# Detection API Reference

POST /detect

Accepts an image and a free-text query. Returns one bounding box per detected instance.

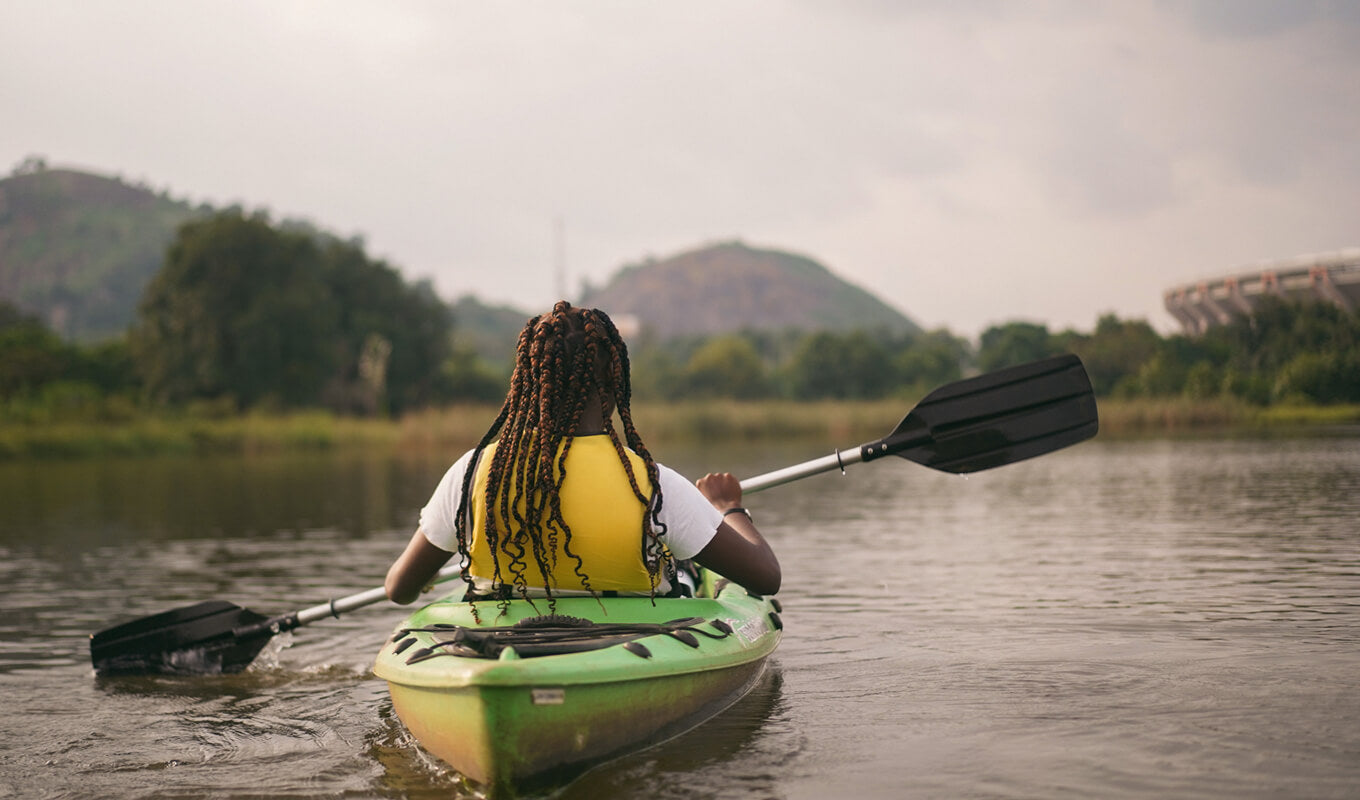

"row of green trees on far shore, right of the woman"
[622,298,1360,405]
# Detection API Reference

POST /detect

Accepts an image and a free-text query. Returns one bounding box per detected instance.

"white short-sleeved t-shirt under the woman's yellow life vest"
[420,450,722,592]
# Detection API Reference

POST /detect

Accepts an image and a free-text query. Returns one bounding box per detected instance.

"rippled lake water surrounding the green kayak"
[0,429,1360,800]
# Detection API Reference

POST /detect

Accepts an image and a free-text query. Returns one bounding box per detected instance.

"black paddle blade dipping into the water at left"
[90,600,273,675]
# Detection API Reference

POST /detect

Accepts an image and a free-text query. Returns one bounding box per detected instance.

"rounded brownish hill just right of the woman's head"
[581,242,921,337]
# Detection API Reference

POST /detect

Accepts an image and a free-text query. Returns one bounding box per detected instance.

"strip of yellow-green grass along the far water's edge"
[0,399,1360,459]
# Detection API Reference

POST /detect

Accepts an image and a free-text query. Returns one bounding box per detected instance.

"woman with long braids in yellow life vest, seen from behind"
[385,301,781,604]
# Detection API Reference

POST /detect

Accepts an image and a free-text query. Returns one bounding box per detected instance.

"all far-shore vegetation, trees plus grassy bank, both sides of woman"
[0,210,1360,457]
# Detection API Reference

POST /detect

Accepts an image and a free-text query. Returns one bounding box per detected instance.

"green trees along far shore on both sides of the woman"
[0,210,1360,420]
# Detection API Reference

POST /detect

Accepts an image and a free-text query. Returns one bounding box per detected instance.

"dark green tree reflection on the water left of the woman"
[0,452,447,547]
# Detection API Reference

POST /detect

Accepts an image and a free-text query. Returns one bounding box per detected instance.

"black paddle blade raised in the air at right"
[862,354,1099,473]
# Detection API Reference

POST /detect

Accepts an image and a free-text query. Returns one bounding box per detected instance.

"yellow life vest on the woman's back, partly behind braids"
[469,435,651,592]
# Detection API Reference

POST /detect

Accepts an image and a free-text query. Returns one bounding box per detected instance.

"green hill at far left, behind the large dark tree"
[0,159,197,341]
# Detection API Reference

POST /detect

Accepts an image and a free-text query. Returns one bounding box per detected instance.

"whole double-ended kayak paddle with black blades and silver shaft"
[90,355,1098,675]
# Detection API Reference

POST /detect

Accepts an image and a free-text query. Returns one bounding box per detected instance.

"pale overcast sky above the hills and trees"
[0,0,1360,337]
